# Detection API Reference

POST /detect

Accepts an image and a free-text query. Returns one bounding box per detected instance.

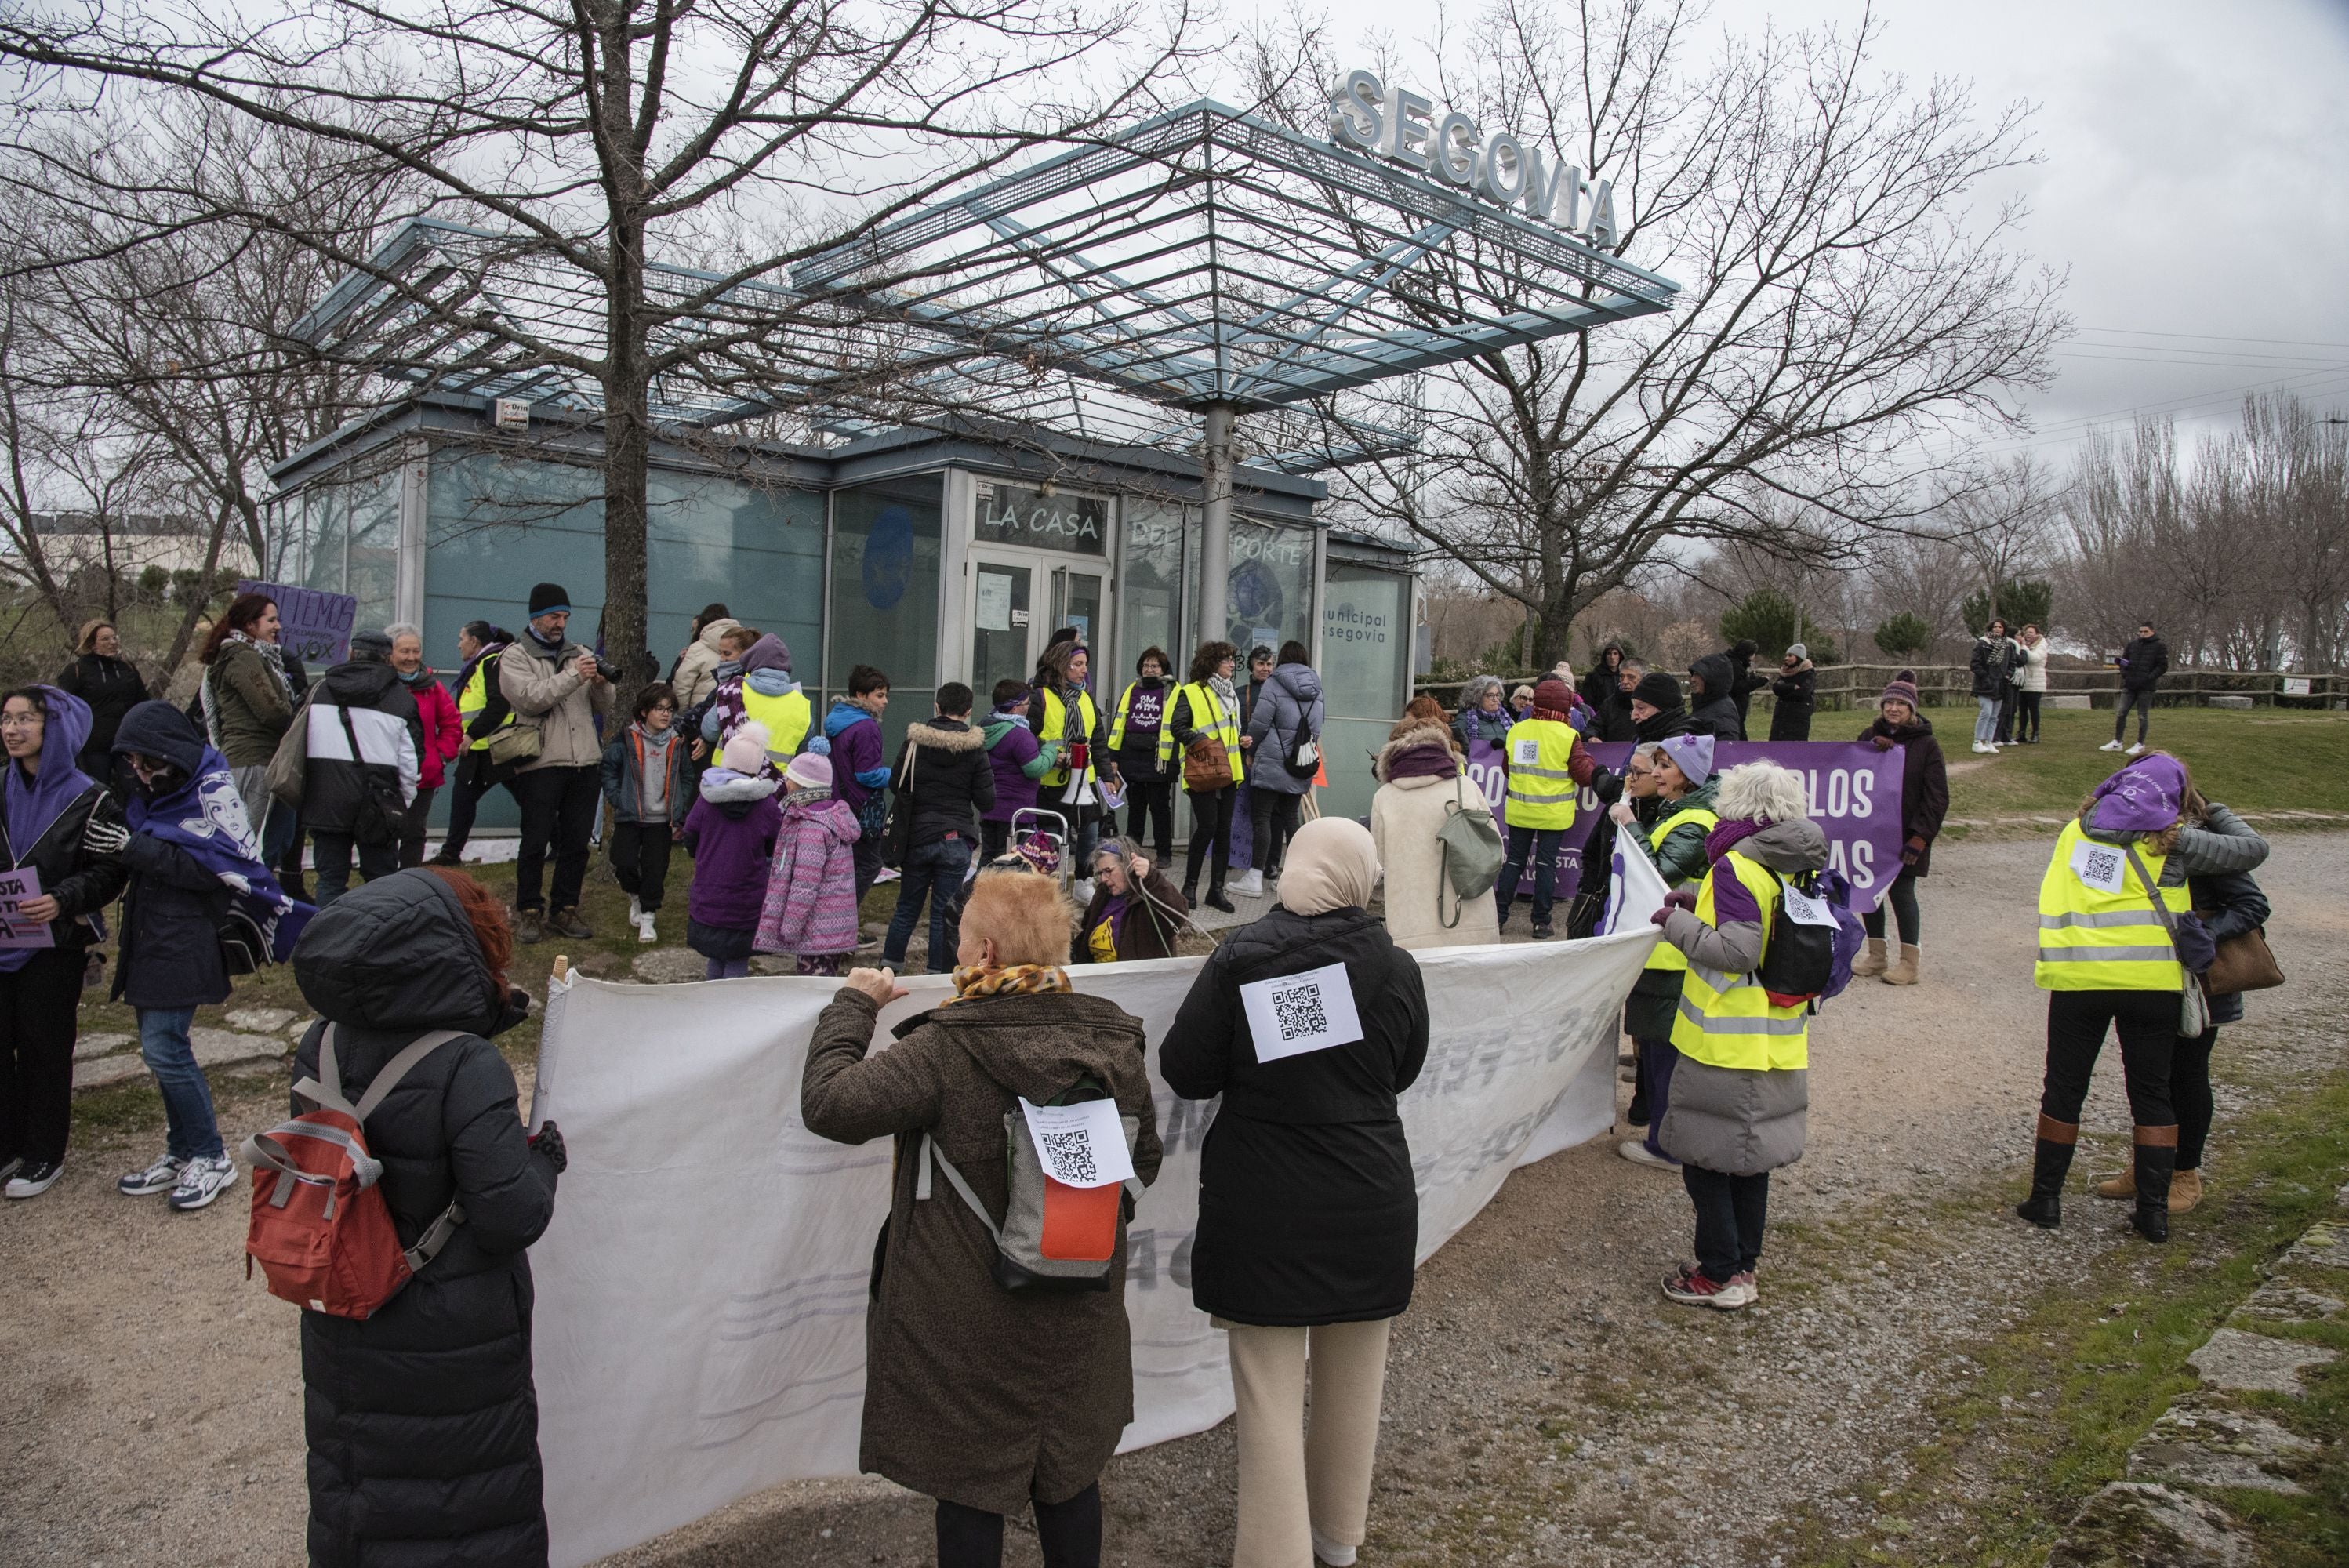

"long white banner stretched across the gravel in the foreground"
[531,925,1656,1568]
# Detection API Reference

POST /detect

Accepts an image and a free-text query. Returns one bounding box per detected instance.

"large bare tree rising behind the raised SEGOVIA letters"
[1292,0,2064,662]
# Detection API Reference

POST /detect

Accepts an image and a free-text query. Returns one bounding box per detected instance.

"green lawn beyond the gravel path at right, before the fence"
[1926,706,2349,836]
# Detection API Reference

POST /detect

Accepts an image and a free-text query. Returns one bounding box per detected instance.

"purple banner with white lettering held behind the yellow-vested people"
[1469,739,1903,911]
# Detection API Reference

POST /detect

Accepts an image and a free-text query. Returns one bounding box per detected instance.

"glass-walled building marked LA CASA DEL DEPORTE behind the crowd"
[273,392,1417,831]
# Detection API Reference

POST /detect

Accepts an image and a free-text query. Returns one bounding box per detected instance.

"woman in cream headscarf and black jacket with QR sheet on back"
[1158,817,1429,1568]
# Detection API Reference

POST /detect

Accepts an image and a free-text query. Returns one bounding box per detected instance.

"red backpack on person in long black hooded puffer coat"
[245,1023,465,1319]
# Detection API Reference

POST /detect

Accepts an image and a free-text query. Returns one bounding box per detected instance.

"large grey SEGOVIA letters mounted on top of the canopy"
[1330,71,1623,251]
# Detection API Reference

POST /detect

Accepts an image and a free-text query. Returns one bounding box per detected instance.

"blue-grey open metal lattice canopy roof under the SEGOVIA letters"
[294,101,1677,472]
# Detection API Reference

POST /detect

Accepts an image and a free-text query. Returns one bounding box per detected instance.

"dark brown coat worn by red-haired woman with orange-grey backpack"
[801,990,1158,1514]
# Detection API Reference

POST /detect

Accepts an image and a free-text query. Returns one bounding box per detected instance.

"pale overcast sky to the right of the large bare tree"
[1287,0,2349,465]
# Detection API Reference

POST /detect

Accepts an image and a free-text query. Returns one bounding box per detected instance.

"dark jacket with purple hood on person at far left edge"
[0,688,129,970]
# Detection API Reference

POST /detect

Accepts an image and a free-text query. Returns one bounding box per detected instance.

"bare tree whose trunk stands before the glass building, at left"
[0,0,1189,699]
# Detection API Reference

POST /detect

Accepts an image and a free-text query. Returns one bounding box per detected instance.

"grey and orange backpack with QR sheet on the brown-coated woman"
[913,1077,1142,1291]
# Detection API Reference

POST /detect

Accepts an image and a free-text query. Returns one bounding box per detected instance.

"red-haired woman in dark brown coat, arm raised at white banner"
[799,871,1158,1568]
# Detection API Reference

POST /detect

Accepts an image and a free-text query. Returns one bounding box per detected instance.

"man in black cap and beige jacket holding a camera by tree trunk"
[498,583,620,942]
